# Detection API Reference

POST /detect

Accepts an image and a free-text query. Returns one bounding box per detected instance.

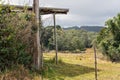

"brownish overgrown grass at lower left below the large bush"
[0,65,41,80]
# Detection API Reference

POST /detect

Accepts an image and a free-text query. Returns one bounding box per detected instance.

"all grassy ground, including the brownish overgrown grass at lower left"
[0,49,120,80]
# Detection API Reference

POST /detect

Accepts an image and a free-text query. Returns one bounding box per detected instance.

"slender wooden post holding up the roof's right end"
[53,14,58,64]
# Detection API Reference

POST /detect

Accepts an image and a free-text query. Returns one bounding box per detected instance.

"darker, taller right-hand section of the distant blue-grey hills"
[80,26,104,32]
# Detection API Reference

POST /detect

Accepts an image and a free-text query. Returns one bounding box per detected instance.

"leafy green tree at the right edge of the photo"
[97,14,120,62]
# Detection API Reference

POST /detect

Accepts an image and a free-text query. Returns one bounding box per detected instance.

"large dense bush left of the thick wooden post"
[0,6,32,71]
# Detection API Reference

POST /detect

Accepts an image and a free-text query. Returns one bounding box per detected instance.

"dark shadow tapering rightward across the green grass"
[42,60,100,80]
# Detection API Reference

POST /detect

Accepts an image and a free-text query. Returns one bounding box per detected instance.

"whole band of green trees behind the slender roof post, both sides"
[42,26,97,52]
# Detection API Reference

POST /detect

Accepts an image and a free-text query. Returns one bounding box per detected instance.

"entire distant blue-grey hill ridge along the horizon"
[63,26,104,32]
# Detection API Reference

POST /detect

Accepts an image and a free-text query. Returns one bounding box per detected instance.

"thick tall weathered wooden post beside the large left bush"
[33,0,42,70]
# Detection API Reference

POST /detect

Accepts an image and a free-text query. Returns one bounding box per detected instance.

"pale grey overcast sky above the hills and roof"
[1,0,120,27]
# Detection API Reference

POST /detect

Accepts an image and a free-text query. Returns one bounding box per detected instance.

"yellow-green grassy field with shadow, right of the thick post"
[43,49,120,80]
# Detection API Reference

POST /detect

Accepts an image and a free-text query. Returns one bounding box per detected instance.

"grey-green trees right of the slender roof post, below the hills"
[58,30,96,51]
